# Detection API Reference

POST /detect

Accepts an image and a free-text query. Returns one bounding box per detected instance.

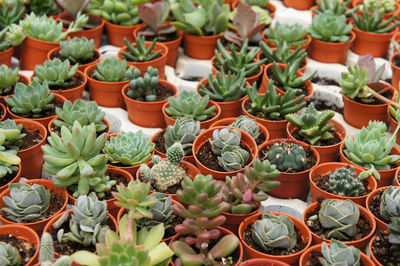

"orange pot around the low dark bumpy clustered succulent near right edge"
[310,162,376,206]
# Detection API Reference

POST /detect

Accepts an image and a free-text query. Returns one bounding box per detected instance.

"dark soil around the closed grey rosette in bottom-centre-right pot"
[243,220,307,256]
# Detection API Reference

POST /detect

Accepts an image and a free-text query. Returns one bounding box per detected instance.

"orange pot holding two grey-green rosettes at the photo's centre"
[192,126,258,180]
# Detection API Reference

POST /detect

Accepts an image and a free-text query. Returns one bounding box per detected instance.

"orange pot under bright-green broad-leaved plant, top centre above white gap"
[183,33,221,60]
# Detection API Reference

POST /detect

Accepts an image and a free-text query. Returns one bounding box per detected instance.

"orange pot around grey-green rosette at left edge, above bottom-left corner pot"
[0,179,68,234]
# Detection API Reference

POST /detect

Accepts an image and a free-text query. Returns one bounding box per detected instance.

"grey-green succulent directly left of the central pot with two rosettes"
[164,115,203,156]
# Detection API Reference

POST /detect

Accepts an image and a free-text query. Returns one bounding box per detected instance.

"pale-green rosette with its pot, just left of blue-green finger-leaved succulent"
[85,56,133,107]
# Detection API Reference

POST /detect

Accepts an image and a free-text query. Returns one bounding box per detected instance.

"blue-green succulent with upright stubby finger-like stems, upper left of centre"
[126,66,160,102]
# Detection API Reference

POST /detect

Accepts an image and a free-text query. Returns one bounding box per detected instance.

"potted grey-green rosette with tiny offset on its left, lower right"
[303,199,376,249]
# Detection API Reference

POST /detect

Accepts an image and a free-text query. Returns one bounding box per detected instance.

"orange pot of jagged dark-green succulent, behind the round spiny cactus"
[286,119,346,163]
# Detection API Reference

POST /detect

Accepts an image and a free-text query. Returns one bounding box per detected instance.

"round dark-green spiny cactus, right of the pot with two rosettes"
[265,142,307,172]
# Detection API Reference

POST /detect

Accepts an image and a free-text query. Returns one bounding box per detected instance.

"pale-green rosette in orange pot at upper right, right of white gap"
[309,10,355,64]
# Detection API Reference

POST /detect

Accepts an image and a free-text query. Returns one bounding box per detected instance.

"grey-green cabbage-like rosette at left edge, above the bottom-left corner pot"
[2,183,50,223]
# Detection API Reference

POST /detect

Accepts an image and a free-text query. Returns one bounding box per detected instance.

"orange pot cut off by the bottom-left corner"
[0,224,40,266]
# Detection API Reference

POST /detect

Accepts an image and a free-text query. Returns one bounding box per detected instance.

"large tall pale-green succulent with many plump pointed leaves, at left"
[41,121,116,198]
